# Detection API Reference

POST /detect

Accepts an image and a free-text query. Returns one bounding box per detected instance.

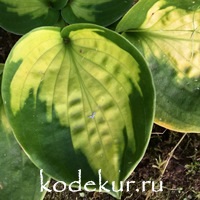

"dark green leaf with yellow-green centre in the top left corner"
[0,0,67,34]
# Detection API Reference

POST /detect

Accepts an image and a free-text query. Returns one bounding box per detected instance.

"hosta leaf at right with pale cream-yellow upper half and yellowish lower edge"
[117,0,200,132]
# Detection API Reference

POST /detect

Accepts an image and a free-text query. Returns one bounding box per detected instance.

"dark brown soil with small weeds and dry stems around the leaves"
[0,29,200,200]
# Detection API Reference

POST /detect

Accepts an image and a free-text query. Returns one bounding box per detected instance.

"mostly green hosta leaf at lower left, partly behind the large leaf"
[0,64,48,200]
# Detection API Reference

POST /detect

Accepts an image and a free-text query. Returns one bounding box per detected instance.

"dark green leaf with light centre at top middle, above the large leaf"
[62,0,133,26]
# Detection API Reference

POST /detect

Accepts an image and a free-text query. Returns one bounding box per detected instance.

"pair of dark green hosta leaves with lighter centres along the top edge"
[0,0,133,34]
